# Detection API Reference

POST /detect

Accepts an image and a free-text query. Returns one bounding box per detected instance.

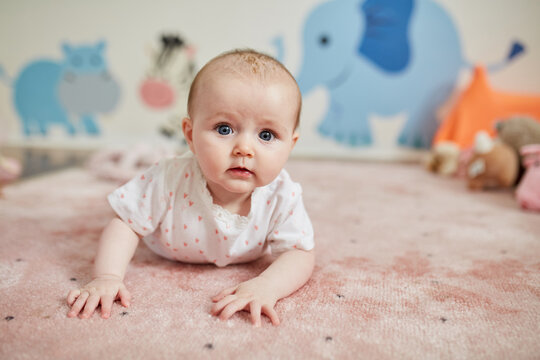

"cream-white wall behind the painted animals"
[0,0,540,158]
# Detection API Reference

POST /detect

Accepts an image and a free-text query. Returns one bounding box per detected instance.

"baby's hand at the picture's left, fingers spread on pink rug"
[67,275,131,319]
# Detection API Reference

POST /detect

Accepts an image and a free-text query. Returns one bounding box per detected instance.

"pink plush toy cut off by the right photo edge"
[516,144,540,211]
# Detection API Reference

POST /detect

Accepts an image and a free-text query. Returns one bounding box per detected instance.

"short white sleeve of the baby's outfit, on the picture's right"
[267,182,315,254]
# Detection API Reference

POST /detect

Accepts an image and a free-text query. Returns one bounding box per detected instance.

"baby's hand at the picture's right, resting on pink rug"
[212,277,279,327]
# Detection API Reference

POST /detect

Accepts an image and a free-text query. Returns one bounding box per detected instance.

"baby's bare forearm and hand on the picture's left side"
[67,218,139,319]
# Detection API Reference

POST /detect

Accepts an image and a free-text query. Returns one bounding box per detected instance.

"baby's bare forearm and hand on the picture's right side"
[212,250,315,327]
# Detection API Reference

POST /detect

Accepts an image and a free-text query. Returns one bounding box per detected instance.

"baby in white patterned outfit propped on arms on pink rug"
[67,50,314,326]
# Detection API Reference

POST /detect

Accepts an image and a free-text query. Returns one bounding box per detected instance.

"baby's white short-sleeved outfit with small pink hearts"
[108,152,314,266]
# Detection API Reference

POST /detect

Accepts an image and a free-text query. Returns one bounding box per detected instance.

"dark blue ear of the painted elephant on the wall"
[358,0,414,73]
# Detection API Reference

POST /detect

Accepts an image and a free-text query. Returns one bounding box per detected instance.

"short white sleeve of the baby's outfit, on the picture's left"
[107,160,174,236]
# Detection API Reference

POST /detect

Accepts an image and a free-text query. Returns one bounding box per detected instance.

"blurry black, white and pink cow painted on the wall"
[140,34,195,138]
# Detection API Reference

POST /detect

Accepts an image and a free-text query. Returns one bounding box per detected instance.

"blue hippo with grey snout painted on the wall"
[5,42,120,136]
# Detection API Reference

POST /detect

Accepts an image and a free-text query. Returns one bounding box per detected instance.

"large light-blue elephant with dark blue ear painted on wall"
[297,0,523,148]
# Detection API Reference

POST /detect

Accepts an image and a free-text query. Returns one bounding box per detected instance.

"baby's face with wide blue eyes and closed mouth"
[183,73,298,200]
